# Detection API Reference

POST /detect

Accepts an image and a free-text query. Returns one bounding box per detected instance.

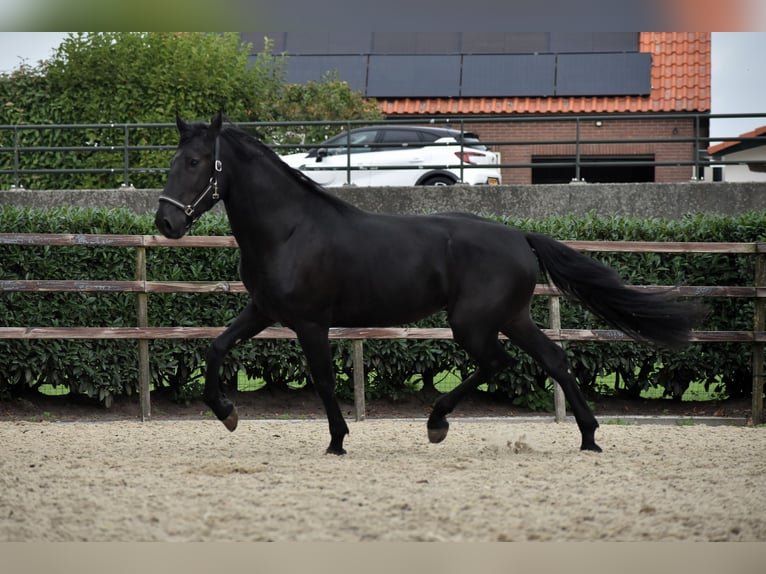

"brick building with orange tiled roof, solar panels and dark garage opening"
[242,32,711,184]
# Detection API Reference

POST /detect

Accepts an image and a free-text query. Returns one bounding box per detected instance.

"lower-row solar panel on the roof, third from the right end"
[366,55,460,98]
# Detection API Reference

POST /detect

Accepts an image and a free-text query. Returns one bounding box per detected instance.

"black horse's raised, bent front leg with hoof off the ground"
[203,303,271,431]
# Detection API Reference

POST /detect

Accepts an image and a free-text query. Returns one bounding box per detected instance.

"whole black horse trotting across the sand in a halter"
[156,113,708,454]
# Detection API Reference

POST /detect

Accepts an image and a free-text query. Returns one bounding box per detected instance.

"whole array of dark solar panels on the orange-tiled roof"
[255,32,651,98]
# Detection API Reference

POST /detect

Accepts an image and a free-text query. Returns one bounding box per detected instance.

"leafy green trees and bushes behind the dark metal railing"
[0,32,380,189]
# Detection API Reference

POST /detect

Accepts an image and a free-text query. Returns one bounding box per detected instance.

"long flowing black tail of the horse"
[525,233,704,347]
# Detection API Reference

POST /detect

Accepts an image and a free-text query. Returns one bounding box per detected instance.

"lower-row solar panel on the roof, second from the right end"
[460,54,556,97]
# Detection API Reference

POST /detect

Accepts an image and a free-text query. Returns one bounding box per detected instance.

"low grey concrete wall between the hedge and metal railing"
[0,182,766,219]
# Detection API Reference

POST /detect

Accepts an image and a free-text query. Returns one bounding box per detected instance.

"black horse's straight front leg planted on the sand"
[295,324,348,454]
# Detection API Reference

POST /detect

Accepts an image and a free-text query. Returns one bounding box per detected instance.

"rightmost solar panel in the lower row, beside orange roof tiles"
[556,53,652,96]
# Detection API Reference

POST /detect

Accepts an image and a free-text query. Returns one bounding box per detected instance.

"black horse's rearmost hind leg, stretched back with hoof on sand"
[502,317,601,452]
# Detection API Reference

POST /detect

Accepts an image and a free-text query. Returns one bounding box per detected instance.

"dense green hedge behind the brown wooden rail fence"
[0,207,766,407]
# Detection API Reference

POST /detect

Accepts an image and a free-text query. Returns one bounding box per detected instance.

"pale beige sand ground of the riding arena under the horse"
[0,419,766,542]
